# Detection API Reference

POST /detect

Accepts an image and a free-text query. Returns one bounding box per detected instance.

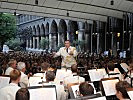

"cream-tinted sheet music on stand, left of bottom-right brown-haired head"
[102,79,119,96]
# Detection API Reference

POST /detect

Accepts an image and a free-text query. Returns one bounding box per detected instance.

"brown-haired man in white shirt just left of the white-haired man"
[5,59,17,75]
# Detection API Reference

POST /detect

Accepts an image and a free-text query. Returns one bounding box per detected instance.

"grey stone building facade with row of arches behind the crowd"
[17,13,133,55]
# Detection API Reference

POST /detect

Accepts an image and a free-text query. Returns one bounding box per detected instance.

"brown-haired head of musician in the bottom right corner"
[115,81,130,100]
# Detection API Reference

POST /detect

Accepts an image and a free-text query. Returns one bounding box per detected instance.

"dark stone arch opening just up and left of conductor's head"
[58,19,67,45]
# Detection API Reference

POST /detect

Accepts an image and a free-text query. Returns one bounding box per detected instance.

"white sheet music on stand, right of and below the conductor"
[88,69,106,82]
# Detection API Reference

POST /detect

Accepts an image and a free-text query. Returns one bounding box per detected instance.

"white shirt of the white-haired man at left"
[19,72,29,88]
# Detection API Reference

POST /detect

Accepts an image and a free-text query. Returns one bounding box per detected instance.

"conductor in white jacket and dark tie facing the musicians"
[54,40,78,68]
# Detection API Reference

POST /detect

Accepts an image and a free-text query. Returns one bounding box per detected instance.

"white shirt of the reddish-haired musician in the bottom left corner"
[0,83,20,100]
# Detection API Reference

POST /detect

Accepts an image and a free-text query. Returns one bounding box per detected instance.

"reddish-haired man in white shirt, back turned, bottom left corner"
[0,69,21,100]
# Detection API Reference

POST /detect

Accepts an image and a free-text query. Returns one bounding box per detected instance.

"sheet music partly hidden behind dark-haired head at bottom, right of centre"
[71,83,96,98]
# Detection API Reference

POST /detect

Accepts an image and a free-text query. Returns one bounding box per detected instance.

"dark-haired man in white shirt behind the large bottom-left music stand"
[44,71,66,100]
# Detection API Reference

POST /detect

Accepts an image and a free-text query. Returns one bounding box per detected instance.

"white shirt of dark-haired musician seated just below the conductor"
[64,73,85,86]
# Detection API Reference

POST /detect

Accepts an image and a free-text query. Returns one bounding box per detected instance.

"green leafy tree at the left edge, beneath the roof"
[0,13,16,47]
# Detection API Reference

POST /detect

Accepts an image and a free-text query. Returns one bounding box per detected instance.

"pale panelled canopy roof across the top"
[0,0,133,21]
